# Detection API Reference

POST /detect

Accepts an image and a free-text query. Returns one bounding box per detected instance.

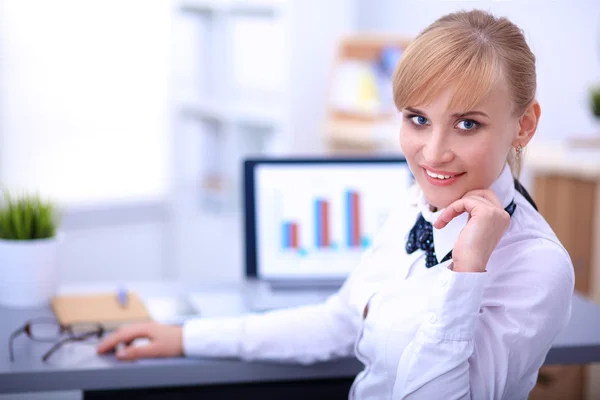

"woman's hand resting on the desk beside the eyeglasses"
[97,322,183,360]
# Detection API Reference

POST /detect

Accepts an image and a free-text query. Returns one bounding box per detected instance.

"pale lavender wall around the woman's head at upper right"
[358,0,600,140]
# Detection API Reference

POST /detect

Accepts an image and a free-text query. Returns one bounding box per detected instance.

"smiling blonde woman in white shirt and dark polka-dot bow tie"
[98,11,574,400]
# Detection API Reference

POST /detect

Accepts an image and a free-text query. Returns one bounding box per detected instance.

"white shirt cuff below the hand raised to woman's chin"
[420,263,489,340]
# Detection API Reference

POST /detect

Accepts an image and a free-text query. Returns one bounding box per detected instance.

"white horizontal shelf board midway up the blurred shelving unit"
[182,101,284,125]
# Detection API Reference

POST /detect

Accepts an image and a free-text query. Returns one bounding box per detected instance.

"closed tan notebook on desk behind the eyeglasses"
[51,292,152,329]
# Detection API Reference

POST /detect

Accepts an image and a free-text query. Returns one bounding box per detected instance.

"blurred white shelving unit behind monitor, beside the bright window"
[175,0,290,211]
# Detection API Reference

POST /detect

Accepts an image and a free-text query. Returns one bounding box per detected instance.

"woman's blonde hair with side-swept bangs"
[393,10,536,177]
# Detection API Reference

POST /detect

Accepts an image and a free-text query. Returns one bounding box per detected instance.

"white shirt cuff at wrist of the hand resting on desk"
[183,317,244,357]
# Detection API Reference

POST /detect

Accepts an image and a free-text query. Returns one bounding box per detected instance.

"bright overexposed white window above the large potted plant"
[0,0,171,203]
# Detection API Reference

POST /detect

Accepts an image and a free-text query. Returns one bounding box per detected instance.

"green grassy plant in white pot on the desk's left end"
[0,191,59,308]
